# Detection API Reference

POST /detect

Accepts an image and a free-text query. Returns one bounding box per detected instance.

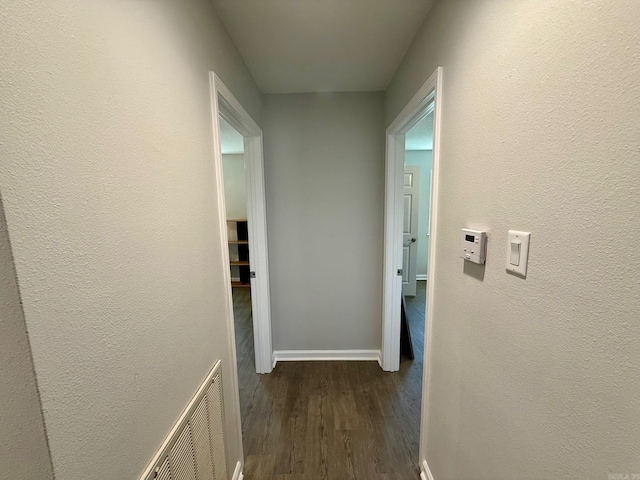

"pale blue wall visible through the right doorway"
[404,150,433,275]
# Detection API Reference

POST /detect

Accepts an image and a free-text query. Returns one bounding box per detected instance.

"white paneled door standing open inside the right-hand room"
[402,165,420,296]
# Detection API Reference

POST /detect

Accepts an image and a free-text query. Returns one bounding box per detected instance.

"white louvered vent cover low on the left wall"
[142,362,228,480]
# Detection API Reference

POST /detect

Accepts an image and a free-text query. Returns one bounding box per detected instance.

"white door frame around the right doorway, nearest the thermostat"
[381,67,442,376]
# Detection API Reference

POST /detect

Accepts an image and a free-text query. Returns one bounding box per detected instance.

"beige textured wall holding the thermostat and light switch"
[386,0,640,480]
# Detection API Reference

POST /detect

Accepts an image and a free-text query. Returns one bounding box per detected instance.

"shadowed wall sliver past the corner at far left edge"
[0,193,53,480]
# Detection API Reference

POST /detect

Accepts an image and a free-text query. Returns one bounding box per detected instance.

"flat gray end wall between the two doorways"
[262,92,384,350]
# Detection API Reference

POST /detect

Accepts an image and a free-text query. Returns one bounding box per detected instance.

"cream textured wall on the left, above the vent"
[0,0,261,480]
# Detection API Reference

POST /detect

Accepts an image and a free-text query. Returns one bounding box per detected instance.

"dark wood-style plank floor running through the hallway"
[233,282,426,480]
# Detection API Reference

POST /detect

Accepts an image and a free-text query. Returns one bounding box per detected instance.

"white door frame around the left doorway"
[209,72,273,376]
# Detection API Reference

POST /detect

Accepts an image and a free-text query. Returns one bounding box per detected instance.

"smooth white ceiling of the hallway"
[213,0,433,93]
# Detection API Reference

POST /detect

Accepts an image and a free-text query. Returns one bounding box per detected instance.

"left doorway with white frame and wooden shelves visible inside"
[210,72,273,388]
